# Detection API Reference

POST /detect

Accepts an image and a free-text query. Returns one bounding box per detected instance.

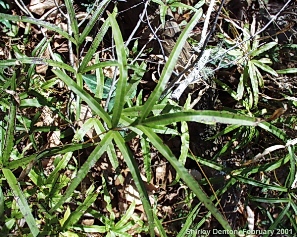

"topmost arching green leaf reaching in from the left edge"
[0,13,77,44]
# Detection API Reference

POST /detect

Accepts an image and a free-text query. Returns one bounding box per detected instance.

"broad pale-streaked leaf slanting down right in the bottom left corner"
[2,168,39,237]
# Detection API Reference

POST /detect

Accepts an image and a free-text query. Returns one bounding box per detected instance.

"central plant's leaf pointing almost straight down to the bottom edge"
[114,132,155,237]
